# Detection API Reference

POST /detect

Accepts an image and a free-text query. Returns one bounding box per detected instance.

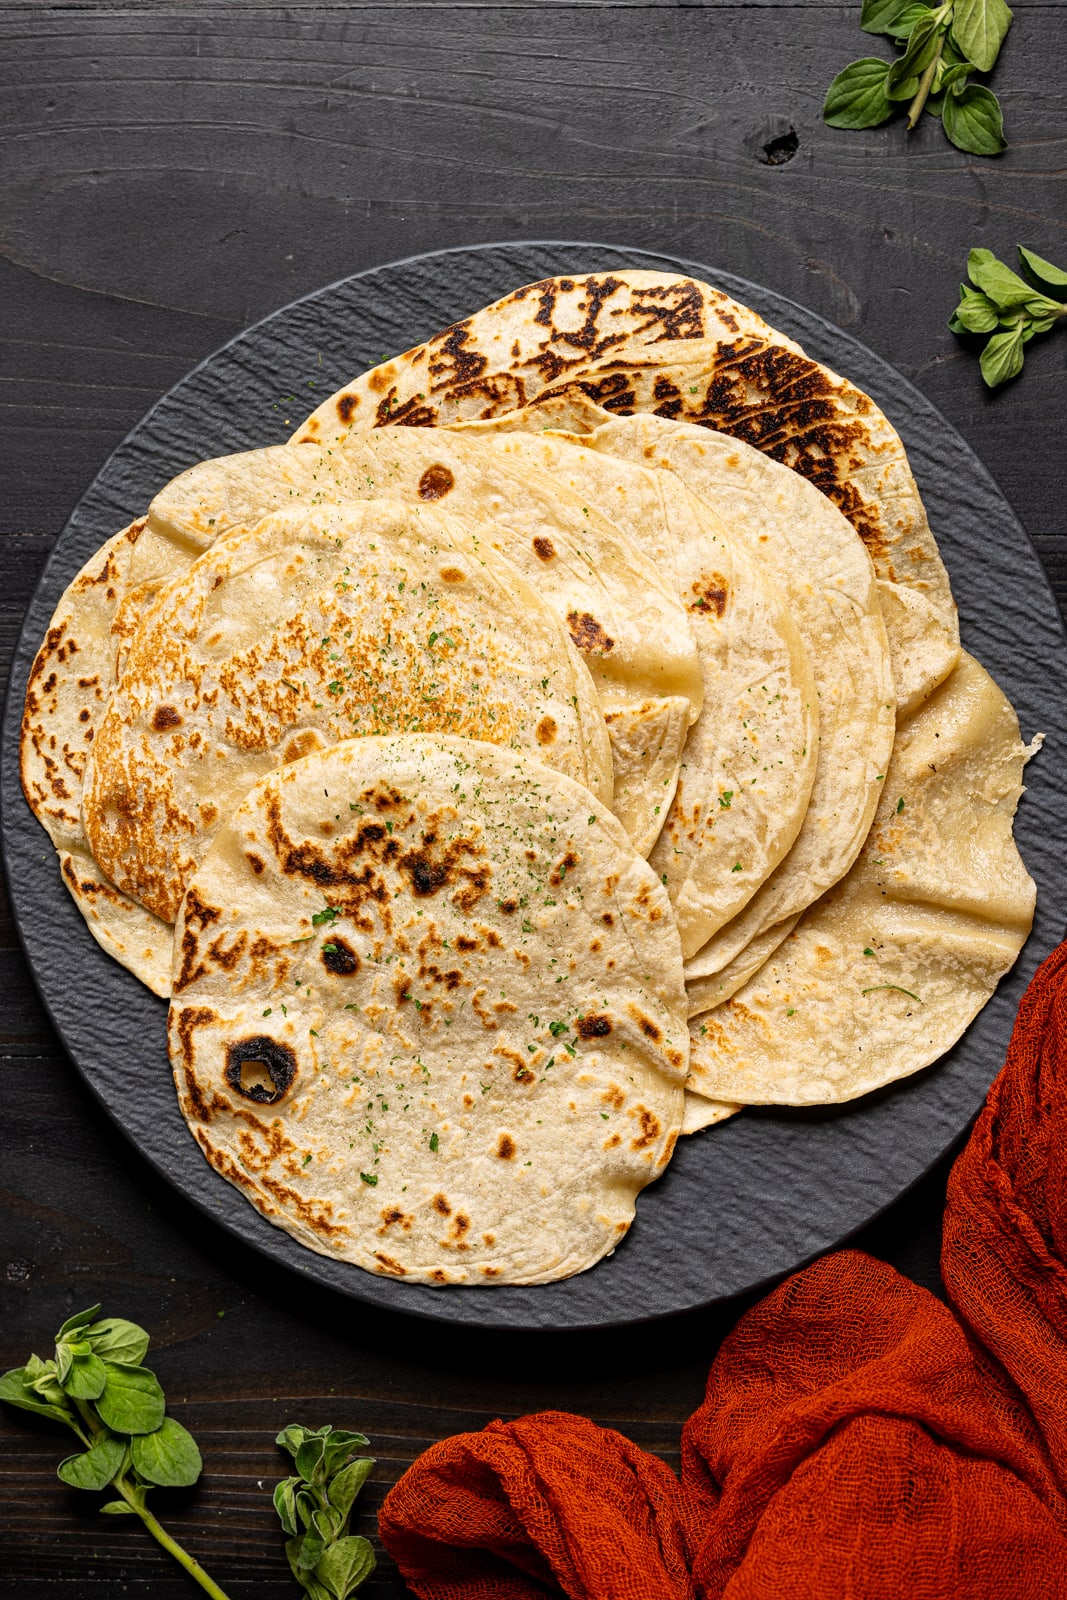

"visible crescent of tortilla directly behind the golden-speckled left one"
[143,429,702,854]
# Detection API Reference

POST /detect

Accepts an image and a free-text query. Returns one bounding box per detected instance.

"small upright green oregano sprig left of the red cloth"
[274,1422,374,1600]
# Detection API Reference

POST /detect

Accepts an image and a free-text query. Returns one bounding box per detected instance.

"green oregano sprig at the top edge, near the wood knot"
[822,0,1013,155]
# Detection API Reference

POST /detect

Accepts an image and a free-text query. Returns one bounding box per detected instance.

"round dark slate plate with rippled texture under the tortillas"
[2,243,1067,1328]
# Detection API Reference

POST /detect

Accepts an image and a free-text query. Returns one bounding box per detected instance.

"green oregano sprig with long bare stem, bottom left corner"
[0,1306,227,1600]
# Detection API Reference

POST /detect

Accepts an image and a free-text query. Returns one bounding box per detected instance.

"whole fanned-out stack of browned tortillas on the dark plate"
[22,272,1033,1283]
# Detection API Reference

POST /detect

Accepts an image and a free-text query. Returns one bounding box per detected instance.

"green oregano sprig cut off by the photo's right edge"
[949,245,1067,389]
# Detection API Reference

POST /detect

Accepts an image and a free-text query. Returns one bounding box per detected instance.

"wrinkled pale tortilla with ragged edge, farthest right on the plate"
[689,654,1035,1106]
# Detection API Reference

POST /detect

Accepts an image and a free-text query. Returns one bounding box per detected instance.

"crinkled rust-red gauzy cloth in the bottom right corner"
[379,944,1067,1600]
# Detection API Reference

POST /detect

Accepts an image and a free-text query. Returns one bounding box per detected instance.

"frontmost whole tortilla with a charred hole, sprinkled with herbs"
[170,736,688,1285]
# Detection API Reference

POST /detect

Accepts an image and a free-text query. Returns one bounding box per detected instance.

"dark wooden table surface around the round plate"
[0,0,1067,1600]
